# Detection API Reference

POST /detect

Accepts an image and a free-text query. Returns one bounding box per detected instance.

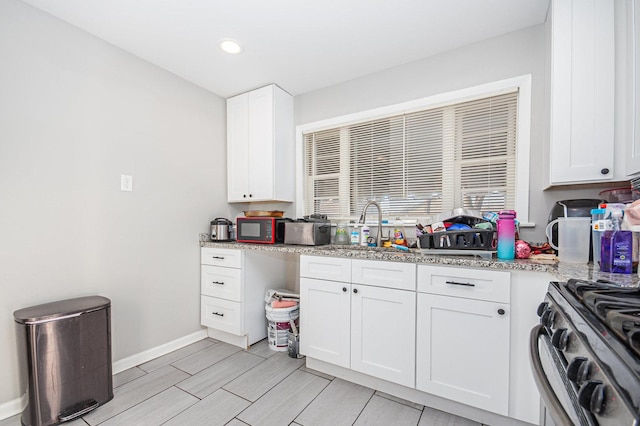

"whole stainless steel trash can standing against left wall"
[13,296,113,426]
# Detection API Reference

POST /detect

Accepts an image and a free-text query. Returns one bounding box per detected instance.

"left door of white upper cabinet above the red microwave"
[227,93,249,202]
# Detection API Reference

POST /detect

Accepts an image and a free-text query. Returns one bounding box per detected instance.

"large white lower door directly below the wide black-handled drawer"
[416,293,509,416]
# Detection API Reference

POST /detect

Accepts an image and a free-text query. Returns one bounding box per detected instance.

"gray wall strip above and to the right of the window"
[295,25,616,242]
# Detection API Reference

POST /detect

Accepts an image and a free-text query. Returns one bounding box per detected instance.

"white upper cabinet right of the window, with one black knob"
[546,0,624,185]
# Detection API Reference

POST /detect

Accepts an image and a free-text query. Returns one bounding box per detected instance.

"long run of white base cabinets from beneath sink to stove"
[300,255,551,425]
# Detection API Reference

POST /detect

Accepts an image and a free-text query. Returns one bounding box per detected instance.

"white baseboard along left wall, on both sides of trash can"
[0,329,207,420]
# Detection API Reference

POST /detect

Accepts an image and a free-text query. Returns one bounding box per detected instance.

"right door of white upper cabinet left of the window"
[248,86,274,201]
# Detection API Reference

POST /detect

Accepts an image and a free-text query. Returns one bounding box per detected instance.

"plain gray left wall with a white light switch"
[0,0,230,405]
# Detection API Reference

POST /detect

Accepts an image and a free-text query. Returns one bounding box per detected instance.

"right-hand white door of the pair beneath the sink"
[351,284,416,388]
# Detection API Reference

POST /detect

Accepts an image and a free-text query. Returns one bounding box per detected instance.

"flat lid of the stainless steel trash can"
[13,296,111,324]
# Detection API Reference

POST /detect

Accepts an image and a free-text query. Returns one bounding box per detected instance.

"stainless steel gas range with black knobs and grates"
[531,280,640,426]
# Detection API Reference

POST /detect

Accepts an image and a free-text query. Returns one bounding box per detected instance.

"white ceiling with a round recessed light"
[23,0,549,97]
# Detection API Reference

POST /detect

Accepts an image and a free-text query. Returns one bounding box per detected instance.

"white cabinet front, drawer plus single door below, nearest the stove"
[416,265,510,416]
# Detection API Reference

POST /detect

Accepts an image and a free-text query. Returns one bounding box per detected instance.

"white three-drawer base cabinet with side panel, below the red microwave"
[200,247,286,349]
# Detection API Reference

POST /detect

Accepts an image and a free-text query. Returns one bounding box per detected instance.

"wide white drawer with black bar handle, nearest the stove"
[418,265,511,303]
